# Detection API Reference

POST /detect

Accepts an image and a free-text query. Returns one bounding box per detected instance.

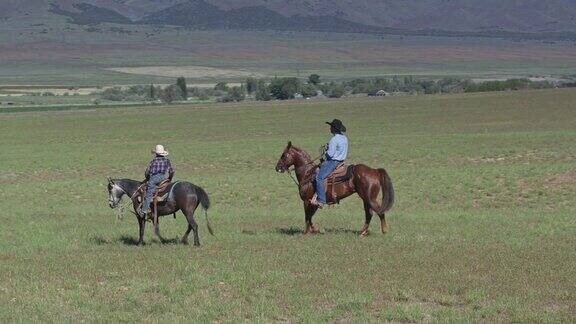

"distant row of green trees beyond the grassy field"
[100,74,555,103]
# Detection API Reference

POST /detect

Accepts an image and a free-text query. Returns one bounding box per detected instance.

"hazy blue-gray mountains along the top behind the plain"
[0,0,576,33]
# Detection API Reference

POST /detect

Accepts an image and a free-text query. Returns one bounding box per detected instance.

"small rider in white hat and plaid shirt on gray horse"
[138,144,175,218]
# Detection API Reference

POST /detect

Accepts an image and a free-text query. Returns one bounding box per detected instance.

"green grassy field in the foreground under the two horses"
[0,90,576,322]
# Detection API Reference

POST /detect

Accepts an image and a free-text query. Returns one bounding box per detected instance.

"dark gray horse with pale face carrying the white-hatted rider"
[108,178,214,246]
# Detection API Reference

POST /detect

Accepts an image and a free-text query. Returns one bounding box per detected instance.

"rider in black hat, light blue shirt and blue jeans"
[310,119,348,206]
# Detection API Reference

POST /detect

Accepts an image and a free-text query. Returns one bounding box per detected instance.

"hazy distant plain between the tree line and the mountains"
[0,22,576,87]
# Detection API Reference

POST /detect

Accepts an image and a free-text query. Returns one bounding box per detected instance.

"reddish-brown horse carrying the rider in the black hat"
[276,142,394,236]
